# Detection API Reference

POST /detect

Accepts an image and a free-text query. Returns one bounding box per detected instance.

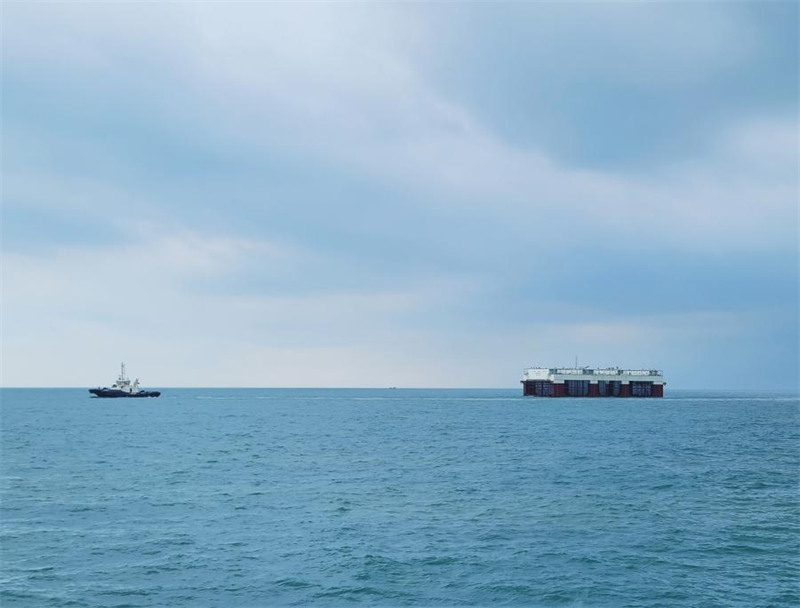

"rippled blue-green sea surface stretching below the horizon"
[0,389,800,608]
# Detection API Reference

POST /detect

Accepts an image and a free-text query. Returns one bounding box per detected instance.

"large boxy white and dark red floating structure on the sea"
[521,366,666,397]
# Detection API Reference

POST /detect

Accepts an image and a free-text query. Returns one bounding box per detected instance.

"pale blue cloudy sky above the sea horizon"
[0,1,800,390]
